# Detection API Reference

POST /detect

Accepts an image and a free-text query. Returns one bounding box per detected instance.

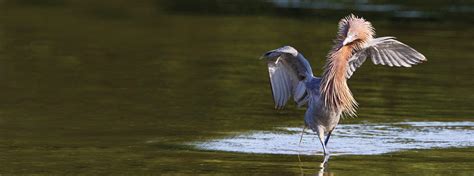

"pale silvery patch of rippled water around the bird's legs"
[191,122,474,155]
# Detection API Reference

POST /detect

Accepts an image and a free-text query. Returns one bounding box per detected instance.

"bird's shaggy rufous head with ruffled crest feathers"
[338,14,375,47]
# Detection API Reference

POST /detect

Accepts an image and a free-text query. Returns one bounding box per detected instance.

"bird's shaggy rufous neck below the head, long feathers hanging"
[320,46,357,116]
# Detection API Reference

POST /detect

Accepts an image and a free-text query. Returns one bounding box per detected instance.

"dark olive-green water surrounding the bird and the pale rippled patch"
[0,0,474,175]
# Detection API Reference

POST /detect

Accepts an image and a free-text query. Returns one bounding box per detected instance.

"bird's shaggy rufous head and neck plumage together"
[320,15,374,116]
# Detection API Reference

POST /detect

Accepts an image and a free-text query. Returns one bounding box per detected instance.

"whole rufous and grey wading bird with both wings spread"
[262,15,426,163]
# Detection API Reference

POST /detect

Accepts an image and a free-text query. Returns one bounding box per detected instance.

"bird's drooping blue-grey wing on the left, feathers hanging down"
[262,46,313,109]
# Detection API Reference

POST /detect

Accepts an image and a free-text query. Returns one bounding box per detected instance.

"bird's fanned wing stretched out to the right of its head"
[346,37,426,79]
